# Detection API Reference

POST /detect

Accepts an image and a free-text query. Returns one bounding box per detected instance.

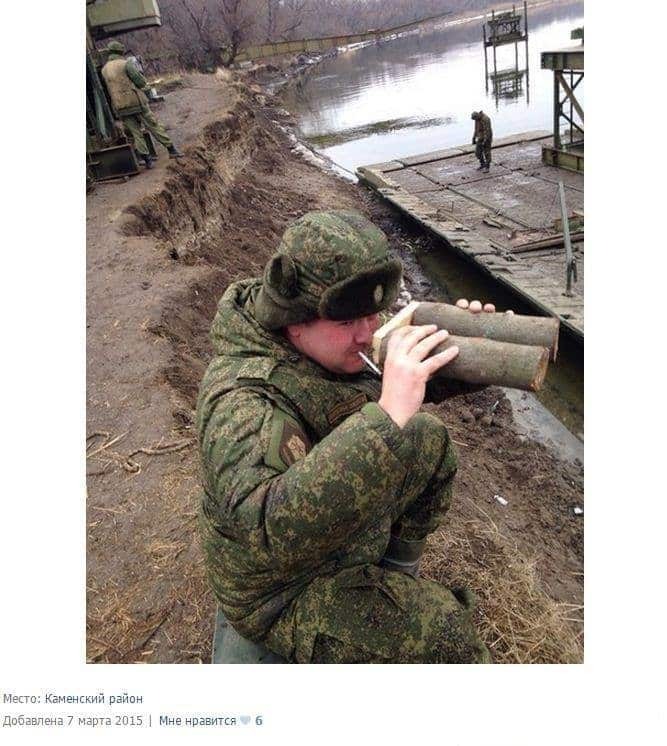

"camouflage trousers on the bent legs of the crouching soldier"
[263,414,491,663]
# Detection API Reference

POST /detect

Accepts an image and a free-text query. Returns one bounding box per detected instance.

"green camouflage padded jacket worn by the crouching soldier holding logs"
[197,280,440,640]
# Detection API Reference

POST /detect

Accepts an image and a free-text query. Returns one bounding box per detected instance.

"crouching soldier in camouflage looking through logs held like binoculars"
[197,211,490,663]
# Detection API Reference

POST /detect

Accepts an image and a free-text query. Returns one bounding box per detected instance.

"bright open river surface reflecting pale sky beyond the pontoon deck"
[286,2,583,172]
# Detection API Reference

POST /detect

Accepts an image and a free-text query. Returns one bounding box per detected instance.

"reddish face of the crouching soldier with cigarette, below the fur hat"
[286,313,380,374]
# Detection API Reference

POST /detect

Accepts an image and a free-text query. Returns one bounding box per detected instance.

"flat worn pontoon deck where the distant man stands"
[357,132,584,340]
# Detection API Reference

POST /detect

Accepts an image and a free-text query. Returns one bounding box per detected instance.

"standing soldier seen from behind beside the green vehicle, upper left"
[102,41,183,168]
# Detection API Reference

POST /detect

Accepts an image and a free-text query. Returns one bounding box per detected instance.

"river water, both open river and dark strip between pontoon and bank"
[286,2,584,439]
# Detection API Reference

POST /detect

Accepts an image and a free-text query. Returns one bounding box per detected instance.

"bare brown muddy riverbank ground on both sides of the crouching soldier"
[86,62,583,663]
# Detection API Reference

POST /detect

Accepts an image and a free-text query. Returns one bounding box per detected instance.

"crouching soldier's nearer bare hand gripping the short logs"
[378,324,459,427]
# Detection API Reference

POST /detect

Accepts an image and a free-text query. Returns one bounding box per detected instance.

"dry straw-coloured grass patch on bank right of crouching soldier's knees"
[422,502,583,663]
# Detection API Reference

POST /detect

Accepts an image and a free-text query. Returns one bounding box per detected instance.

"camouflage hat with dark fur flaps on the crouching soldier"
[255,210,402,329]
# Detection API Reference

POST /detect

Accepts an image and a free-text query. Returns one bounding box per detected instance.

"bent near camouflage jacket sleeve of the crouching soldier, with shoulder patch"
[201,389,414,563]
